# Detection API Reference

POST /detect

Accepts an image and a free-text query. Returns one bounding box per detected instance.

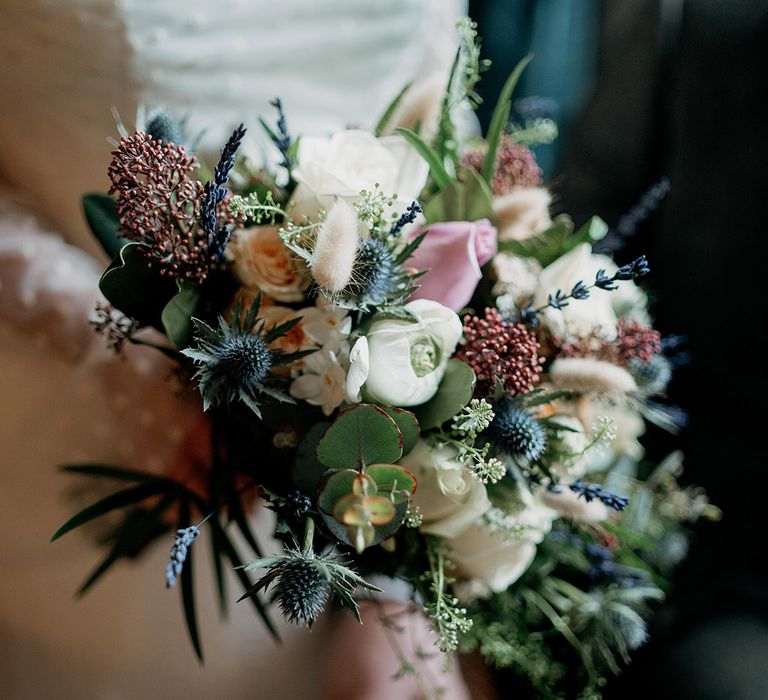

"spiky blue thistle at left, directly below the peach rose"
[182,294,314,416]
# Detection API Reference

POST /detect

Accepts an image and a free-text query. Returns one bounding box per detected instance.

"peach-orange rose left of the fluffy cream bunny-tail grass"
[227,226,305,302]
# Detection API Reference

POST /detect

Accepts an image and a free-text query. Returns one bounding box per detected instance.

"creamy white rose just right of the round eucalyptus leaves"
[400,440,491,537]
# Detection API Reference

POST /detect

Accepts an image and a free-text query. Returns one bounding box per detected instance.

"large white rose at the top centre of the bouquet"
[291,129,429,219]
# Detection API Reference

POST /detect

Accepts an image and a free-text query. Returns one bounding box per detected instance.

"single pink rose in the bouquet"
[406,219,497,311]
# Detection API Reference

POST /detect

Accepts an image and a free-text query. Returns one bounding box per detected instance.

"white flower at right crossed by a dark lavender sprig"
[533,243,644,340]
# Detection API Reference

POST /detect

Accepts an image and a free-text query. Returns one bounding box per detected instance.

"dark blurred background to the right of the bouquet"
[470,0,768,700]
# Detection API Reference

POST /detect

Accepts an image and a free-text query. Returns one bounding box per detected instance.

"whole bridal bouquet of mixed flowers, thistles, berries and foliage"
[54,24,716,697]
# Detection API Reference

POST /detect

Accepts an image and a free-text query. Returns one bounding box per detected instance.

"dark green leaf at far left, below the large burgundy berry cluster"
[99,243,178,328]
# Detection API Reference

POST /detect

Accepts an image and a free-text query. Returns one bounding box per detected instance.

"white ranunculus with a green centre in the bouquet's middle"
[362,299,462,406]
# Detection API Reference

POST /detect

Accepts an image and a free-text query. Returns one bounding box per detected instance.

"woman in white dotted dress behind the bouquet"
[0,0,474,700]
